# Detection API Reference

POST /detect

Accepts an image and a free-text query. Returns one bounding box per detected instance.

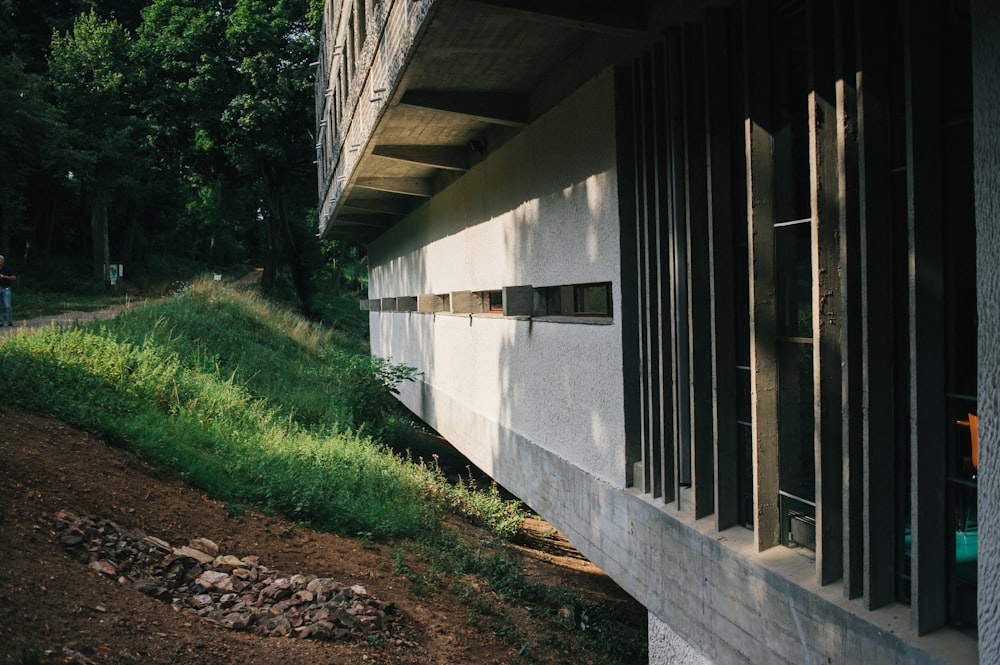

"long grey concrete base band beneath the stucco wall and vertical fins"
[424,389,972,665]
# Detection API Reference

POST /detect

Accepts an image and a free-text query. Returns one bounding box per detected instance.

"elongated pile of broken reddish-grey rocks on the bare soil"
[54,510,412,645]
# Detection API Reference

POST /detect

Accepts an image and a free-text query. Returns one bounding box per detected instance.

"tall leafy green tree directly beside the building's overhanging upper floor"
[138,0,322,310]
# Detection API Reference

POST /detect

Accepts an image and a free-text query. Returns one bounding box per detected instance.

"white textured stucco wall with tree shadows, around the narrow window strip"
[369,72,625,486]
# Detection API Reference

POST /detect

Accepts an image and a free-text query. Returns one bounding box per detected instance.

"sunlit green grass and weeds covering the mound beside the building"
[0,280,635,663]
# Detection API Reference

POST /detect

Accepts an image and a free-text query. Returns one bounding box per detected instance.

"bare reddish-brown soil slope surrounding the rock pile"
[0,411,645,665]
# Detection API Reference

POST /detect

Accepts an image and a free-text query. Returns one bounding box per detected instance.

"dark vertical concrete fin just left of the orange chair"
[903,0,954,635]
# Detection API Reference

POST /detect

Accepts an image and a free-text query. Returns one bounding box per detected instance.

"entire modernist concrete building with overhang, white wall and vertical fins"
[316,0,1000,664]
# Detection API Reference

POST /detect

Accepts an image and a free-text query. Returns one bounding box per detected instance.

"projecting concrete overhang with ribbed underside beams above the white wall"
[320,0,712,241]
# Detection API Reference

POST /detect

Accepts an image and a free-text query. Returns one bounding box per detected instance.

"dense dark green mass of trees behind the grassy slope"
[0,0,362,315]
